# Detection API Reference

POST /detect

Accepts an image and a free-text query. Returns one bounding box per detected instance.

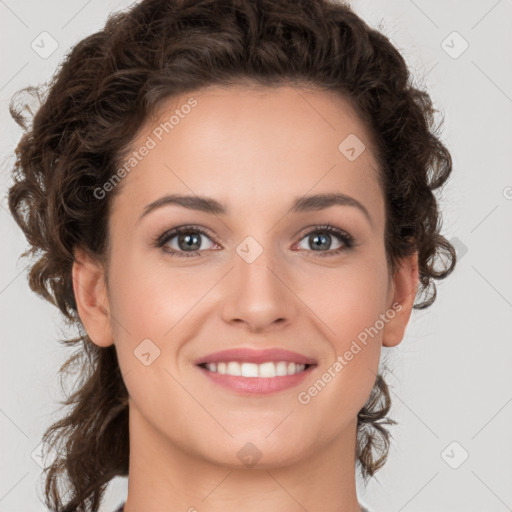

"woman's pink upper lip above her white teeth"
[195,348,316,365]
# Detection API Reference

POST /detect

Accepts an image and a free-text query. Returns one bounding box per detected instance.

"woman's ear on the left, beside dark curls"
[72,245,114,347]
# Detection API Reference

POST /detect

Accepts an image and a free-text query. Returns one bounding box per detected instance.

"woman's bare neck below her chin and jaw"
[124,403,360,512]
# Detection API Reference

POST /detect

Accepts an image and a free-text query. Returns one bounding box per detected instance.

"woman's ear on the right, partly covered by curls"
[382,252,419,347]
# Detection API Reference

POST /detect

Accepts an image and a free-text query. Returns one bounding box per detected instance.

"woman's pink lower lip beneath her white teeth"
[197,365,316,395]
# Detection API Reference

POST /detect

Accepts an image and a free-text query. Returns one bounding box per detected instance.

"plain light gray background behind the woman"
[0,0,512,512]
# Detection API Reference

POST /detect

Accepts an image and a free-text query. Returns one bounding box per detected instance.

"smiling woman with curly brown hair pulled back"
[9,0,455,512]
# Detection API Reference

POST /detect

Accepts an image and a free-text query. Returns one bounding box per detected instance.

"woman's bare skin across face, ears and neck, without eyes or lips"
[73,86,418,512]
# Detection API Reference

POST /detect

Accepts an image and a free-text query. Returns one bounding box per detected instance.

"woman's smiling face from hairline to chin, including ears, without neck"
[74,87,417,472]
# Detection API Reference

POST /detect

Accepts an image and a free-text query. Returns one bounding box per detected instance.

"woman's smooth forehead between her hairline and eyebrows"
[115,86,381,226]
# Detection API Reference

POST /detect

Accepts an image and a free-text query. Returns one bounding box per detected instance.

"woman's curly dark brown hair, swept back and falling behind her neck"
[8,0,456,512]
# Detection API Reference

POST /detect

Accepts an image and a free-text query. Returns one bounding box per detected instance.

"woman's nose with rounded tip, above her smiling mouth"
[222,242,300,332]
